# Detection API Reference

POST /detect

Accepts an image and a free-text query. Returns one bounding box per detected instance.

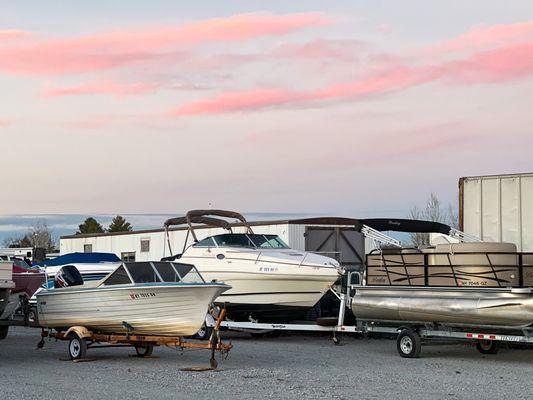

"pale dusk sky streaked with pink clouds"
[0,0,533,225]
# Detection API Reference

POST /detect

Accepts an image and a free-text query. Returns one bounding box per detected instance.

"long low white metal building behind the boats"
[60,217,375,269]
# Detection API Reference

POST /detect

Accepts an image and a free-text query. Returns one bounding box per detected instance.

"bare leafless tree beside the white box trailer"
[409,193,458,247]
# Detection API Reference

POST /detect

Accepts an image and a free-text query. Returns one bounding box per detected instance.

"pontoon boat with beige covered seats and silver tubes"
[352,220,533,328]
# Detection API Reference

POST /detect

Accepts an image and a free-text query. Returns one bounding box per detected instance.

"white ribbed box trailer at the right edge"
[459,173,533,252]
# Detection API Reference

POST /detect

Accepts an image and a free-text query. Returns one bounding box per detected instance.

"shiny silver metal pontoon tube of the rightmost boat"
[352,286,533,327]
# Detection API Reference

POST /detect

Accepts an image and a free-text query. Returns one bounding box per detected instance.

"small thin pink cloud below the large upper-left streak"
[43,80,156,97]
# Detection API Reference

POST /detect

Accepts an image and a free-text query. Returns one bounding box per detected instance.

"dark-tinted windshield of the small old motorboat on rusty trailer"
[104,261,204,286]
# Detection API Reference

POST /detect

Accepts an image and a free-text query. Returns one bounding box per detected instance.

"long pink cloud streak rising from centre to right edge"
[170,42,533,117]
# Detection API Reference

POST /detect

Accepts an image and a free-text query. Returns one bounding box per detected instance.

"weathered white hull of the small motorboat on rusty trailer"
[37,284,227,336]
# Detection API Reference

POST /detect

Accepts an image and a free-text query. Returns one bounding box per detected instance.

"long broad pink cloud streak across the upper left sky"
[0,13,331,75]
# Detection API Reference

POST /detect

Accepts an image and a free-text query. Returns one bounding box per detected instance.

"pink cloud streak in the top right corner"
[428,21,533,53]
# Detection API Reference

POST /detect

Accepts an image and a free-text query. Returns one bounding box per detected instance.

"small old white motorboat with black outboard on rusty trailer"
[37,262,229,336]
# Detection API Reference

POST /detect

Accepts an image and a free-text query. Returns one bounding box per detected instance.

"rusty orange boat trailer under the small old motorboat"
[37,310,233,369]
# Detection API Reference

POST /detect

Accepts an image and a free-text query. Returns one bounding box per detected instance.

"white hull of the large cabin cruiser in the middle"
[180,248,340,321]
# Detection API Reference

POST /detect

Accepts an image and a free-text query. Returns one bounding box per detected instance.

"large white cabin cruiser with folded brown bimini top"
[161,210,340,322]
